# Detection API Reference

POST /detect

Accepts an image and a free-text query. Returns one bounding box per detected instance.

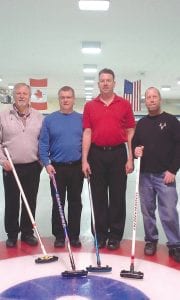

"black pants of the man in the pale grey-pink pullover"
[3,161,42,239]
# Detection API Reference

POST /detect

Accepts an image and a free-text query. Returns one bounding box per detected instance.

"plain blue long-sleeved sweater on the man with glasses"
[39,111,82,166]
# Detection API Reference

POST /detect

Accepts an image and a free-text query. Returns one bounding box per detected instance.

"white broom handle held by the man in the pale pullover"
[4,147,47,256]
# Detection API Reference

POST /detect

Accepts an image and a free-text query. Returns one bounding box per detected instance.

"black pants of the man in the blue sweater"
[50,163,84,239]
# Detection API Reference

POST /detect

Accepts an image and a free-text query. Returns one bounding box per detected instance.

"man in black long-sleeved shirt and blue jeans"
[132,87,180,262]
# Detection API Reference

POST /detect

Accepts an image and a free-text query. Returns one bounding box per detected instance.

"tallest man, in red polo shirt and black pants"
[82,69,135,250]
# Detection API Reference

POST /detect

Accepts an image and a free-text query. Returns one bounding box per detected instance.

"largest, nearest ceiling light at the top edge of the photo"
[79,0,109,10]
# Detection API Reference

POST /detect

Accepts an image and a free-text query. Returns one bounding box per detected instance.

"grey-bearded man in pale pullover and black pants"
[0,83,43,248]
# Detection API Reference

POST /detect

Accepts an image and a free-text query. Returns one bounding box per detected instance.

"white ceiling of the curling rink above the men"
[0,0,180,106]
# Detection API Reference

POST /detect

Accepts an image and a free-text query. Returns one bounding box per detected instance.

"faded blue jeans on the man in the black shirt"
[139,173,180,248]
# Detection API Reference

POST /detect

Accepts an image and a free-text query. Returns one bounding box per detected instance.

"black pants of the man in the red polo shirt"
[89,145,127,241]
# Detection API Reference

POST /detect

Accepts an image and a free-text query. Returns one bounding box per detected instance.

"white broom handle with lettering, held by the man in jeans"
[131,157,141,260]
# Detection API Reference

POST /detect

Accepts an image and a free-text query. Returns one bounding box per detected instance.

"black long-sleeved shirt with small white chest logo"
[132,112,180,174]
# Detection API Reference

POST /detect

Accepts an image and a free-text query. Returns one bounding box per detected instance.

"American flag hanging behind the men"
[124,79,141,111]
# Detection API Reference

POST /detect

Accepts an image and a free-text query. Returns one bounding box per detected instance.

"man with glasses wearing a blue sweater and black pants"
[39,86,84,247]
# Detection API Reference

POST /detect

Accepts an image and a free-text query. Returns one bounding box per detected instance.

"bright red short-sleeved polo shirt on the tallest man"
[83,94,135,146]
